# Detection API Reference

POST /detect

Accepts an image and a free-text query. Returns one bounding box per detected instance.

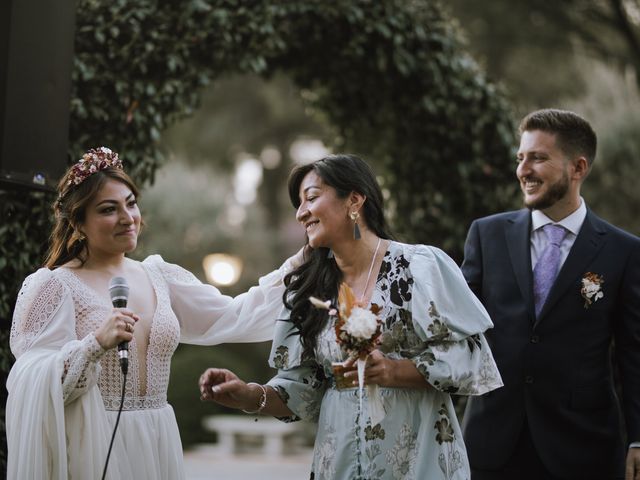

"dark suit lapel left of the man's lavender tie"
[505,210,535,323]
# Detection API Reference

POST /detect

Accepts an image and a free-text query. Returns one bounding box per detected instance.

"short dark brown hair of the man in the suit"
[518,108,598,166]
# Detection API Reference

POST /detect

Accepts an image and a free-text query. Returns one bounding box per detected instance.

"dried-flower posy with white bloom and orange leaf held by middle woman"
[309,283,385,425]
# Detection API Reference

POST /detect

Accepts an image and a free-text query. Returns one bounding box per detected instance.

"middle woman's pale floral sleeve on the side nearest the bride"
[267,316,328,422]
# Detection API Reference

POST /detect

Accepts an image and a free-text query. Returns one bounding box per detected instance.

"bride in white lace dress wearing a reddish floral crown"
[6,147,299,480]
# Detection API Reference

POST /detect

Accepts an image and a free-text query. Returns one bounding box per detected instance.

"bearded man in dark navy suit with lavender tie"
[462,109,640,480]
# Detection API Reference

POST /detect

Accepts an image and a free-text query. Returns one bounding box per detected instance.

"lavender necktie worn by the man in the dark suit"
[533,223,567,317]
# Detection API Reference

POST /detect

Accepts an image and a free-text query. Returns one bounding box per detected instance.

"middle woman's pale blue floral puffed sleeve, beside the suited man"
[409,245,502,395]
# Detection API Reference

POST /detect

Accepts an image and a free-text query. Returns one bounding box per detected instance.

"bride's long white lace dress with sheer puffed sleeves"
[6,255,289,480]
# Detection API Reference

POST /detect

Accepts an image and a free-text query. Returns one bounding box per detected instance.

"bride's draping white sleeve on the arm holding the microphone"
[6,269,129,479]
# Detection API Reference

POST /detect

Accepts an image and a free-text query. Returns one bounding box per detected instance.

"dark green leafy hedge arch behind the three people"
[0,0,515,472]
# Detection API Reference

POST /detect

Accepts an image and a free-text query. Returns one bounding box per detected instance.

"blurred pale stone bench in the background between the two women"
[202,415,299,456]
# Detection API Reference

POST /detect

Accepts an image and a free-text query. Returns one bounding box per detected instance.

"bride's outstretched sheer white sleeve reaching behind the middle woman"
[144,255,291,345]
